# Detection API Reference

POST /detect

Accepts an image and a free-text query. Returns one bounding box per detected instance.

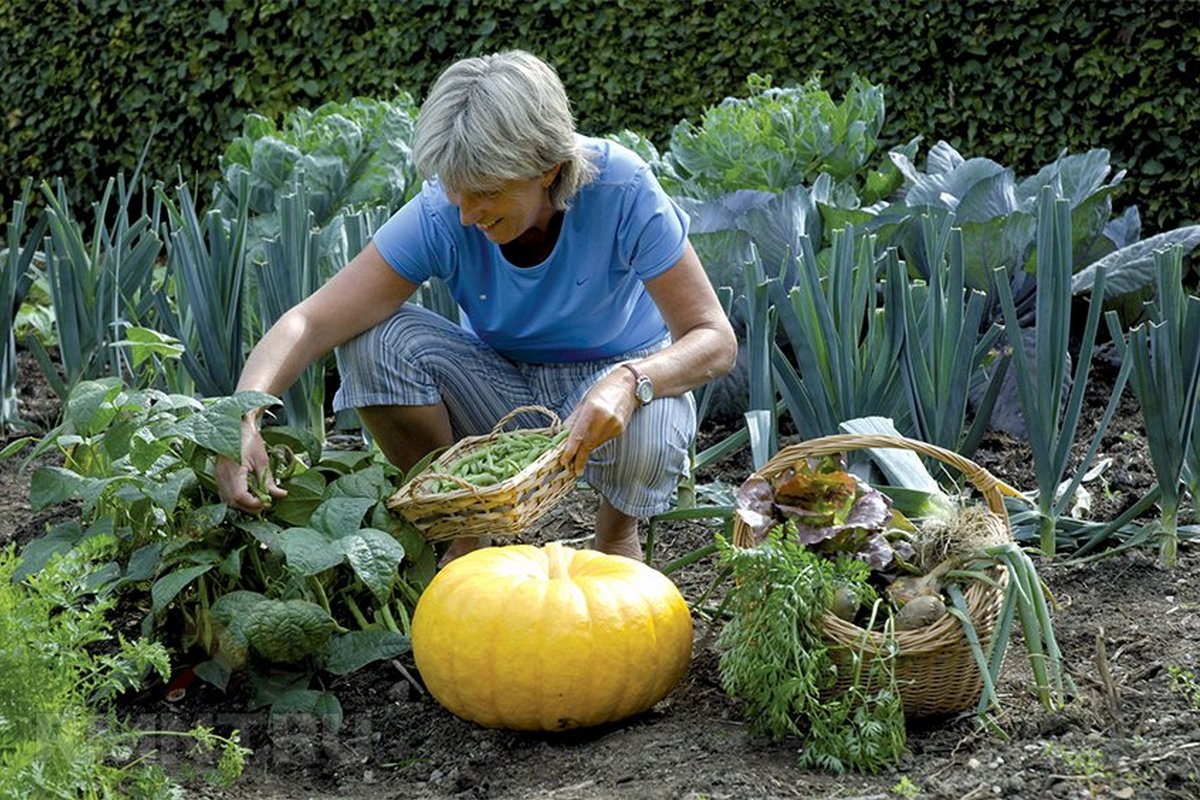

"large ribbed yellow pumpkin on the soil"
[413,542,692,730]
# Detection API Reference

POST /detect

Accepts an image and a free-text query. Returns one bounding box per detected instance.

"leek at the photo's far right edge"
[1105,246,1200,567]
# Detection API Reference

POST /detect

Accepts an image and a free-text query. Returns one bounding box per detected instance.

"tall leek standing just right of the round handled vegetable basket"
[995,186,1129,557]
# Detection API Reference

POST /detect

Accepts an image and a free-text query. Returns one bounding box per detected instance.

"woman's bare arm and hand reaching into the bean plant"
[215,243,418,512]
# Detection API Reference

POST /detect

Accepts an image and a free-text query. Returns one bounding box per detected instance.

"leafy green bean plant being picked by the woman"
[10,379,434,720]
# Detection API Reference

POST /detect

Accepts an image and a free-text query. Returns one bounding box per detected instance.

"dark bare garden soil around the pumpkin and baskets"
[0,352,1200,800]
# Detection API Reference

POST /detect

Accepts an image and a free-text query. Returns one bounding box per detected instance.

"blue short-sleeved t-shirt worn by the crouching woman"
[374,139,688,363]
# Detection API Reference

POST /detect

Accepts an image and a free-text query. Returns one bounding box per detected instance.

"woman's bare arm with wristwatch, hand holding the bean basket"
[563,242,738,475]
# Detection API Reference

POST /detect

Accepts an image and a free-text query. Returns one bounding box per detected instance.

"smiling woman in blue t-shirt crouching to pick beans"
[216,50,737,559]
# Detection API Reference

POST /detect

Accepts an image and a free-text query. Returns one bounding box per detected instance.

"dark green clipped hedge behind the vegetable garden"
[0,0,1200,230]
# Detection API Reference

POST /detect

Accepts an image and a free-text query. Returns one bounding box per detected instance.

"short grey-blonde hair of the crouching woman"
[413,50,596,210]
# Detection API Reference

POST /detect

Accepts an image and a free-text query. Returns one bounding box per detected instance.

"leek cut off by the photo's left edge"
[0,179,47,433]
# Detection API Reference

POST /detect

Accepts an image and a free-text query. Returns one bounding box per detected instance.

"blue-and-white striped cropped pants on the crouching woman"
[334,303,696,518]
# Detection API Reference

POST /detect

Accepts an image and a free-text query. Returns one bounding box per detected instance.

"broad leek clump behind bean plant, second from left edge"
[29,176,162,399]
